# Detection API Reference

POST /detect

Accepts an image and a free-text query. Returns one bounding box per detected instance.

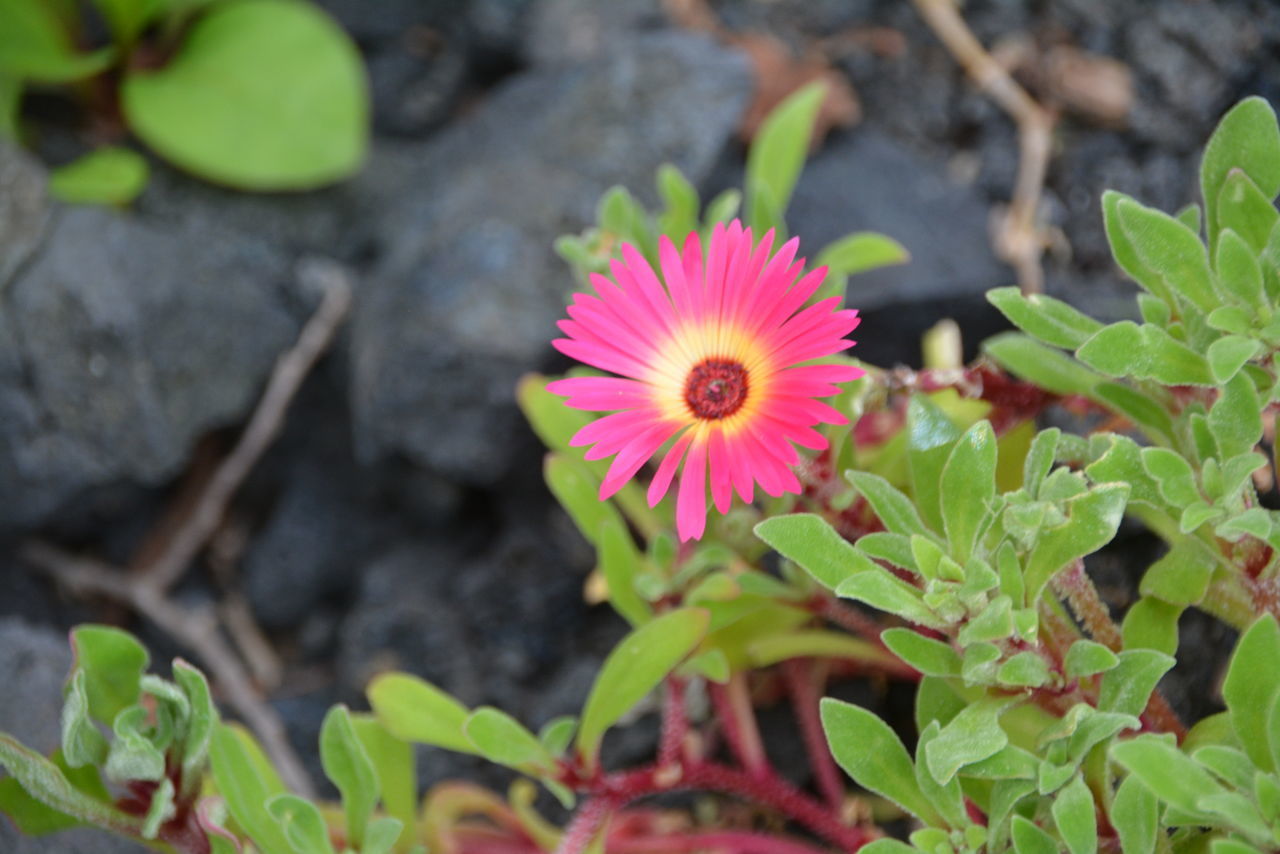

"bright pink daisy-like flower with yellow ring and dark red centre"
[548,220,864,540]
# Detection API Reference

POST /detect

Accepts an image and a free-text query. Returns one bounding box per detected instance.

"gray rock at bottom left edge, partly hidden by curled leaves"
[0,617,147,854]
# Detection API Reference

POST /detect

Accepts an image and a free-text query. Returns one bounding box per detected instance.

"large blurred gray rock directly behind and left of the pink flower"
[351,33,751,485]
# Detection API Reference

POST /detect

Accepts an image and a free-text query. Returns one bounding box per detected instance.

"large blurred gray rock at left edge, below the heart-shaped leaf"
[0,207,298,529]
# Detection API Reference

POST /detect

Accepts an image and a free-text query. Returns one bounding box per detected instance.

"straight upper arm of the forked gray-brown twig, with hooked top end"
[136,260,351,593]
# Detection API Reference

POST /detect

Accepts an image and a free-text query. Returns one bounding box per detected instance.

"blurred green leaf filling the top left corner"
[0,0,115,83]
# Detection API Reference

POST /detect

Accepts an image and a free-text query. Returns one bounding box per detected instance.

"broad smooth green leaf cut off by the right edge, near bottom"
[1222,615,1280,771]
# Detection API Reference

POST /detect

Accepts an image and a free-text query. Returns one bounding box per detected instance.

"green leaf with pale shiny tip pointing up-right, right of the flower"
[1025,484,1129,607]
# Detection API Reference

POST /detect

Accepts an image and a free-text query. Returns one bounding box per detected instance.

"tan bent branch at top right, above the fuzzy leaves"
[913,0,1053,293]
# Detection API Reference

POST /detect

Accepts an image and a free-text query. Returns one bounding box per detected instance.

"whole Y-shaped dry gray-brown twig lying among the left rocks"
[22,261,351,796]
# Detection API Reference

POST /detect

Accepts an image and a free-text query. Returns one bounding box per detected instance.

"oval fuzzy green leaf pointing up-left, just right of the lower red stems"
[820,698,946,827]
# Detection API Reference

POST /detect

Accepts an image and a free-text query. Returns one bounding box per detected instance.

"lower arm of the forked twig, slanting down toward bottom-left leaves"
[20,542,315,798]
